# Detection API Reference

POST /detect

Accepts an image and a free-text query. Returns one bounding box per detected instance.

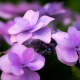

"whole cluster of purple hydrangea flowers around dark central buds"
[0,2,80,80]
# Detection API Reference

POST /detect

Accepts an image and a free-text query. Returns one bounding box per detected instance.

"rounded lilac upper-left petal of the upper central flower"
[14,17,30,30]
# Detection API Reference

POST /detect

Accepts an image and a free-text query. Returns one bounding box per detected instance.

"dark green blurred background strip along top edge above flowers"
[0,0,80,12]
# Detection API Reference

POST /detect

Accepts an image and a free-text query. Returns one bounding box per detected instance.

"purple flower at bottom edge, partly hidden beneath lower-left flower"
[1,68,40,80]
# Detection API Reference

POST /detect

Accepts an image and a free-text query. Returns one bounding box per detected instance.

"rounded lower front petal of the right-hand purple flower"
[62,46,78,62]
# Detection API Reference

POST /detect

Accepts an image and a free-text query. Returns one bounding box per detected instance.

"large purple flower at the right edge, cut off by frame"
[52,26,80,66]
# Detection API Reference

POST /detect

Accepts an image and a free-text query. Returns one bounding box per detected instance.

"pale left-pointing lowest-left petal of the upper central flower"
[8,24,25,34]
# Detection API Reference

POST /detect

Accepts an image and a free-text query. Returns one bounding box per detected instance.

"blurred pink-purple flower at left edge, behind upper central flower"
[0,20,14,45]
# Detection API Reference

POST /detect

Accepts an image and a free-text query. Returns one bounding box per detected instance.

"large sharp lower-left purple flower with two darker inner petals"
[0,43,45,75]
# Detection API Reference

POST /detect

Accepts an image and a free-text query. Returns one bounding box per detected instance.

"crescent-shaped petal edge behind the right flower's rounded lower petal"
[56,46,77,66]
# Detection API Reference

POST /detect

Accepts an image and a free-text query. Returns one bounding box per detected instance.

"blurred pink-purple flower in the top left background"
[0,2,40,19]
